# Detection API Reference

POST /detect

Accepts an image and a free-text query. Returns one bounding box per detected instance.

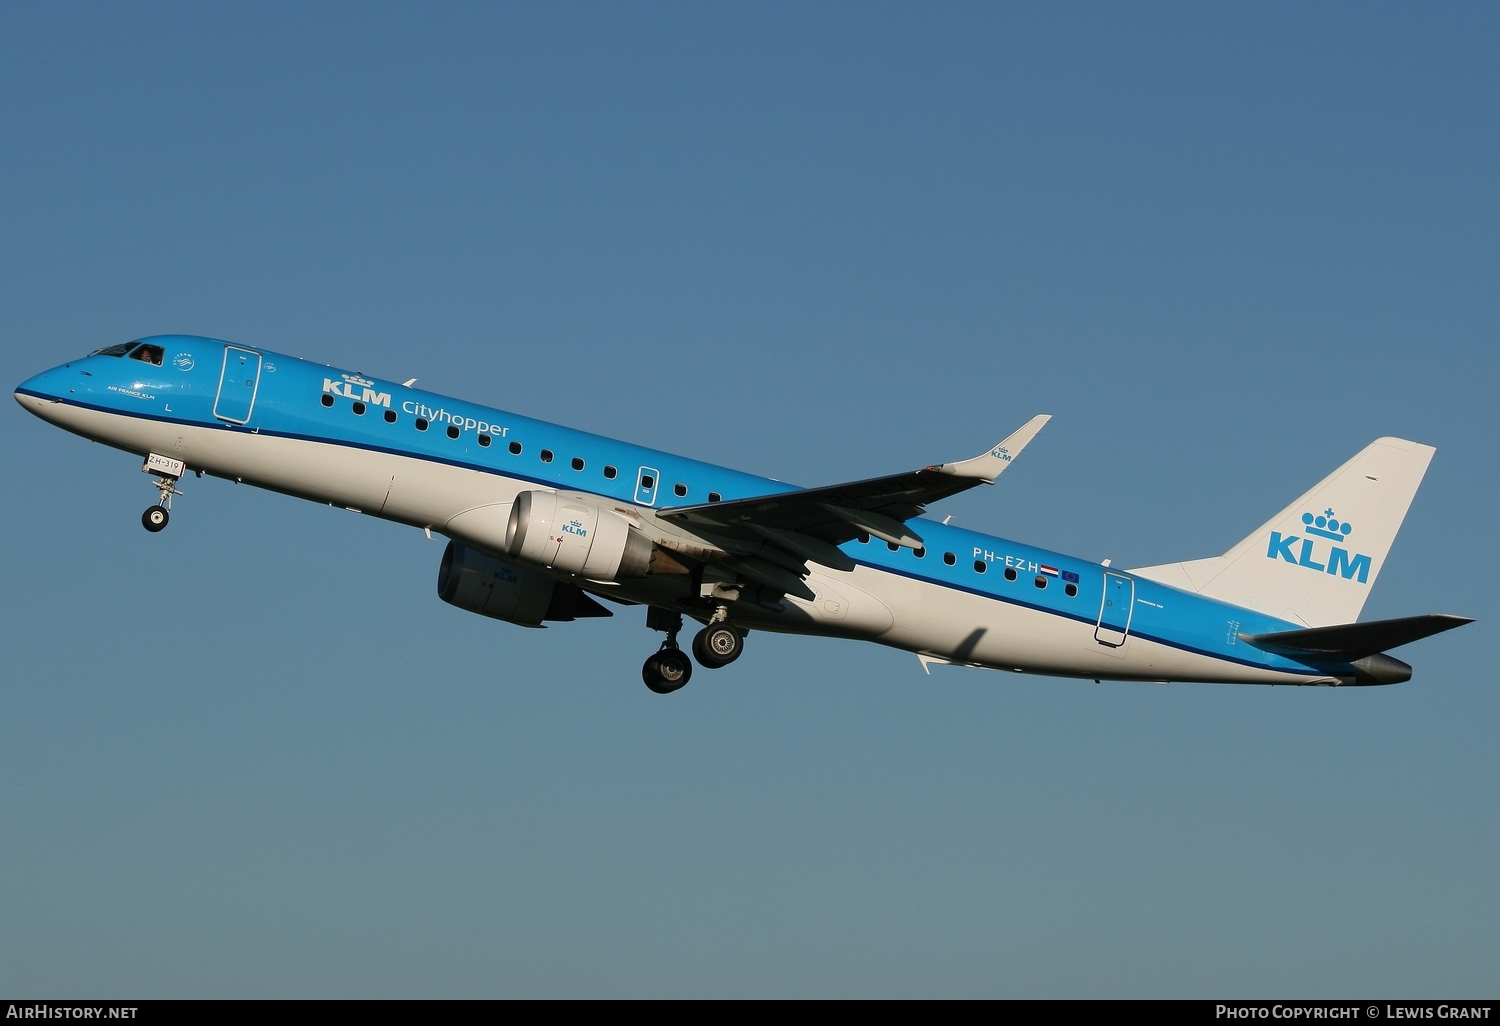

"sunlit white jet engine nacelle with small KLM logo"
[506,492,651,581]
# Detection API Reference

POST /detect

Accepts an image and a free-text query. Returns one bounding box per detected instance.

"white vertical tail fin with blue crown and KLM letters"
[1131,438,1437,627]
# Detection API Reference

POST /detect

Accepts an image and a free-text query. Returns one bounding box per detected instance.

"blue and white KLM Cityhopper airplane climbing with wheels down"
[15,335,1473,695]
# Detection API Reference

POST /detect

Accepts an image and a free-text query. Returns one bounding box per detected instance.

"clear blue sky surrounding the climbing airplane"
[0,3,1500,996]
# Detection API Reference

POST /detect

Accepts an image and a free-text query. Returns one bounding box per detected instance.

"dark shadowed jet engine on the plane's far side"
[438,542,611,627]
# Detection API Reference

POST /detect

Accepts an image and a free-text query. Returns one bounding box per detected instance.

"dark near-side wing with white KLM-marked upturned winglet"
[659,414,1052,566]
